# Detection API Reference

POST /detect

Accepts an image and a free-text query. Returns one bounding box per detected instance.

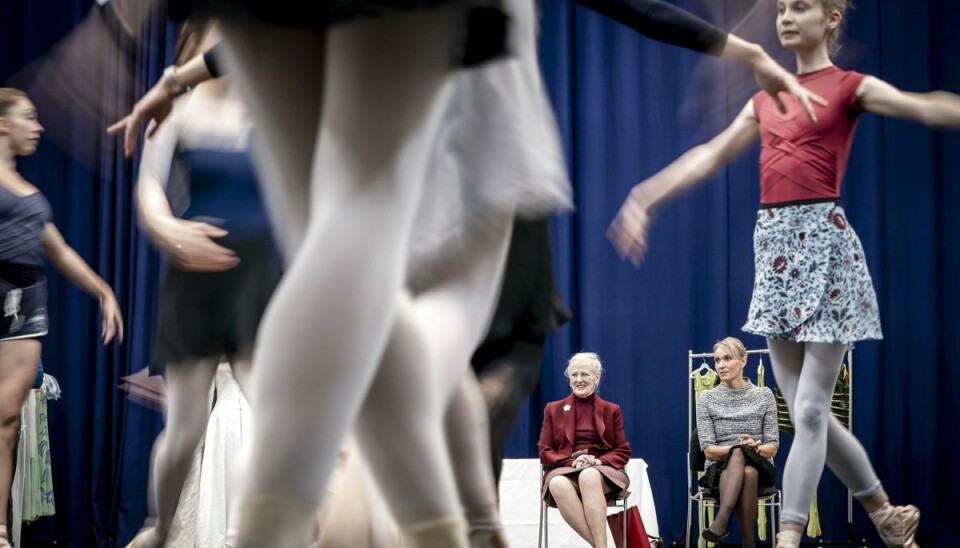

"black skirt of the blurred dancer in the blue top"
[150,235,280,375]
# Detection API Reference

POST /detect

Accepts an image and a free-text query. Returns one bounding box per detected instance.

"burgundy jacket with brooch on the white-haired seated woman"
[537,394,631,471]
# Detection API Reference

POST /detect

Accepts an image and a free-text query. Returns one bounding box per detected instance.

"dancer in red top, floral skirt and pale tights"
[609,0,960,548]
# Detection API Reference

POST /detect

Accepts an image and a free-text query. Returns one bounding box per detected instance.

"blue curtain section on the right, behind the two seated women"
[509,0,960,546]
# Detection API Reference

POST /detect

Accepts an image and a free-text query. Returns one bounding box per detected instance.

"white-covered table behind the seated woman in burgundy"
[500,459,660,548]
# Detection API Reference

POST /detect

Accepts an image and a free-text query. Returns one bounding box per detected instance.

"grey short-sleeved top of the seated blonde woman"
[697,379,780,467]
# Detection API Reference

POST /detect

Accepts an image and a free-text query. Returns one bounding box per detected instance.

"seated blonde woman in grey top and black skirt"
[697,337,780,548]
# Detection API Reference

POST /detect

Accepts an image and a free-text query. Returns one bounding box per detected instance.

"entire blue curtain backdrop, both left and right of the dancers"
[0,0,960,547]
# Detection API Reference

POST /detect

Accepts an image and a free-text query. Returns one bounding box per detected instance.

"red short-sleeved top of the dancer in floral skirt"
[753,66,865,205]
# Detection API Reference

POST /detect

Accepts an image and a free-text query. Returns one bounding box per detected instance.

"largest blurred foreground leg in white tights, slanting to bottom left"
[224,6,464,546]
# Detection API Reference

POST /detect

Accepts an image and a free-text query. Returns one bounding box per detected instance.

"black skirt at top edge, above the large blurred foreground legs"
[168,0,508,66]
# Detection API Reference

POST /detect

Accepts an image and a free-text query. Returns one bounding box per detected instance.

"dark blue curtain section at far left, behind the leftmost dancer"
[0,0,172,547]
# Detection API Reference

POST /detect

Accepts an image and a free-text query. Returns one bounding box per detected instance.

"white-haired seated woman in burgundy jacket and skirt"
[538,352,630,548]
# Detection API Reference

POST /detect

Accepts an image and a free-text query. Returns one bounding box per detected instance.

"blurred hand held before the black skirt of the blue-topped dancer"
[155,218,240,272]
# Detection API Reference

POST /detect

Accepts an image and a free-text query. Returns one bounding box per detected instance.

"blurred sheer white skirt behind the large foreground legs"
[408,0,572,289]
